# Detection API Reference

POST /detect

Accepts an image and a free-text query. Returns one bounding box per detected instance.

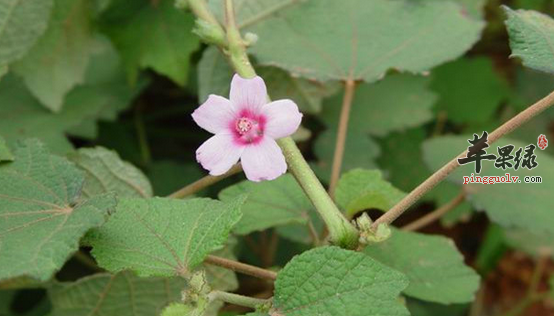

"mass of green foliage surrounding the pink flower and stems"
[0,0,554,316]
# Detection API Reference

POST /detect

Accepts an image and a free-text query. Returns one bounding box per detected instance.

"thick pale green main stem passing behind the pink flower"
[221,0,358,249]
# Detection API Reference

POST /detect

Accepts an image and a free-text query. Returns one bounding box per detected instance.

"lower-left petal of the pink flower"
[196,133,244,176]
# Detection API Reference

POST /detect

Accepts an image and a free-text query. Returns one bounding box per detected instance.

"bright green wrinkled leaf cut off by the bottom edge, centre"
[271,247,409,316]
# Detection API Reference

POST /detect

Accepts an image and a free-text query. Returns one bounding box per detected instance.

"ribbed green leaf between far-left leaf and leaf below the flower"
[68,147,152,198]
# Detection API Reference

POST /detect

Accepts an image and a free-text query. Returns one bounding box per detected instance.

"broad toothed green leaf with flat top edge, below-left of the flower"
[87,198,244,276]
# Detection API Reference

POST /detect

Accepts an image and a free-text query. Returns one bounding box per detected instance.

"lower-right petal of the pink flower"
[240,136,287,182]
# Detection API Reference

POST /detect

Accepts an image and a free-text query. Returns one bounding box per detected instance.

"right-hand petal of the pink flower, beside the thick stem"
[262,100,302,139]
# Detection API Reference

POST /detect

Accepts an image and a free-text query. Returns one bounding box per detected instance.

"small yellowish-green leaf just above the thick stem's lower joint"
[335,169,406,218]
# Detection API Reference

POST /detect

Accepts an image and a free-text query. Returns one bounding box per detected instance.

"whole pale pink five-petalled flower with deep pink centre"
[192,75,302,181]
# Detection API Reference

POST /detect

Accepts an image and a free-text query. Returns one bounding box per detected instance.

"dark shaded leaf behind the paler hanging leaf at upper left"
[0,39,144,153]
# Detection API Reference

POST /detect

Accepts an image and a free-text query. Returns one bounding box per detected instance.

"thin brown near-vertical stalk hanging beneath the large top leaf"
[329,79,356,197]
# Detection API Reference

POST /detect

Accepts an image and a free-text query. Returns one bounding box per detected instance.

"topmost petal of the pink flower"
[229,74,267,114]
